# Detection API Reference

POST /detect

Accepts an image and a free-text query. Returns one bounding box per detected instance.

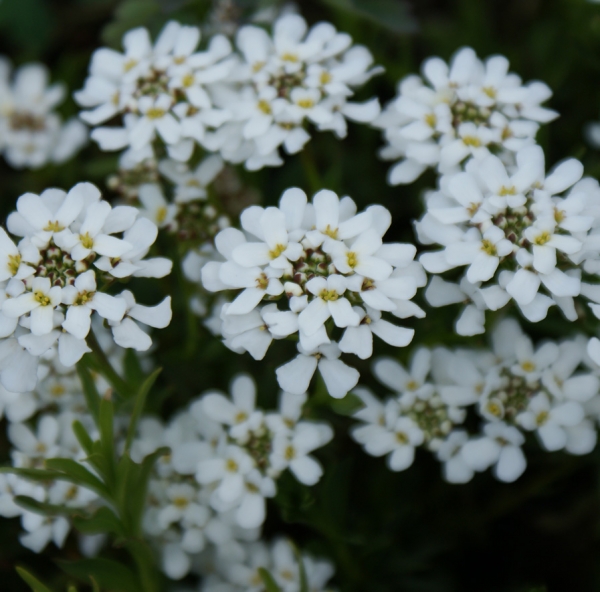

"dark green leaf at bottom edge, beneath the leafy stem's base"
[57,557,141,592]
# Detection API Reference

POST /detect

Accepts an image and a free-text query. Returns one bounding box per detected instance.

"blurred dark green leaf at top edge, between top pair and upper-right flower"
[321,0,417,33]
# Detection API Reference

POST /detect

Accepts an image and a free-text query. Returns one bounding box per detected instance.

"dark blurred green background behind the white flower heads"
[0,0,600,592]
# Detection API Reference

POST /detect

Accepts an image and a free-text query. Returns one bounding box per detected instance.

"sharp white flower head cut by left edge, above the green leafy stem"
[0,183,172,392]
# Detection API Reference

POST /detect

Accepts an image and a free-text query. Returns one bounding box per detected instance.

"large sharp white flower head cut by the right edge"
[416,146,600,335]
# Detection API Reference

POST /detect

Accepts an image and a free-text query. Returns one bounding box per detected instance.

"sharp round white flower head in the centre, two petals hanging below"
[202,188,426,398]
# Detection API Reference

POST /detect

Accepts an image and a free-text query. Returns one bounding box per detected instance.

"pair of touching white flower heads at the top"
[75,14,380,170]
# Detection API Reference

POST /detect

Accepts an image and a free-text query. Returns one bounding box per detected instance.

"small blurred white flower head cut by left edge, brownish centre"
[0,57,88,168]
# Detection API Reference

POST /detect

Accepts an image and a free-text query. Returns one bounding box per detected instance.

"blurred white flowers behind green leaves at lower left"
[0,323,130,554]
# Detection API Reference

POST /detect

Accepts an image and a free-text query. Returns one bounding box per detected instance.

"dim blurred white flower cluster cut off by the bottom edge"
[198,539,334,592]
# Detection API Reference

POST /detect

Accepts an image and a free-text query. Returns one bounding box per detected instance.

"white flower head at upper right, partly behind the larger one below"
[374,47,558,185]
